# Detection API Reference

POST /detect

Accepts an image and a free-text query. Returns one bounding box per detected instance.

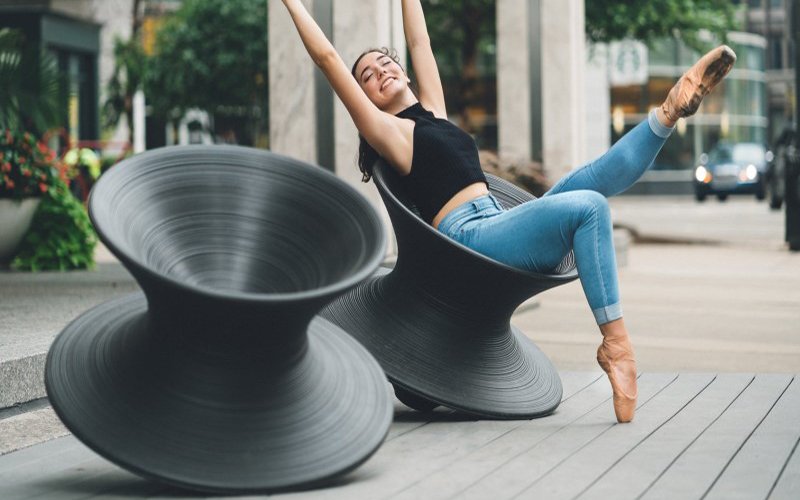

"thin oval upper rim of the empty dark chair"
[87,144,387,304]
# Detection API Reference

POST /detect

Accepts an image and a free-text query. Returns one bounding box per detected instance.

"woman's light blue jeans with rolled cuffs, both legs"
[438,112,673,325]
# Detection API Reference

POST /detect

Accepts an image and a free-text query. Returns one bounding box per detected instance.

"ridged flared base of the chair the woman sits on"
[320,270,562,419]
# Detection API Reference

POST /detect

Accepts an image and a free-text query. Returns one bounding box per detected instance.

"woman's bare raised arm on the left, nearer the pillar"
[283,0,410,162]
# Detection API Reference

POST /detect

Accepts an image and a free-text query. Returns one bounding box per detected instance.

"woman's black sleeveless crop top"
[396,102,488,224]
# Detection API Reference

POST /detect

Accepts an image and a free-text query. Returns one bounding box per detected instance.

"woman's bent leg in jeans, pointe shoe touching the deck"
[454,190,637,422]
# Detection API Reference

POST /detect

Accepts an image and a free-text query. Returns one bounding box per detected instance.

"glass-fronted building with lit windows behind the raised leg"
[609,32,769,193]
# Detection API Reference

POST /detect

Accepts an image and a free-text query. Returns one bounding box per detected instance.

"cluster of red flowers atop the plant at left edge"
[0,129,66,200]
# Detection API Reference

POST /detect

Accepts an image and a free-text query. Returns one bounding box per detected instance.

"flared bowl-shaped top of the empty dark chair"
[89,146,385,301]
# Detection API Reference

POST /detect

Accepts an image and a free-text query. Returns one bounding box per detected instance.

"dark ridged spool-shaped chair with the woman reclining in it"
[322,161,578,419]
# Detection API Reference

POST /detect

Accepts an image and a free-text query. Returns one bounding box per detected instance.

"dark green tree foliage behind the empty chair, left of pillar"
[144,0,268,141]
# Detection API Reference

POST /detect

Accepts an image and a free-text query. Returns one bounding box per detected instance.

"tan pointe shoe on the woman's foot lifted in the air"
[661,45,736,121]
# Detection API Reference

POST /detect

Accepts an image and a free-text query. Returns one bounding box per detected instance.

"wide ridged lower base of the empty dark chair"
[45,293,392,493]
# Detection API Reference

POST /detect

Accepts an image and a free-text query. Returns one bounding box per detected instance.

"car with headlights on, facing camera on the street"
[694,142,772,201]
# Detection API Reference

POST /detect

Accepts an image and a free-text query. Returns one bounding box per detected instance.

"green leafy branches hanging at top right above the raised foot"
[586,0,737,52]
